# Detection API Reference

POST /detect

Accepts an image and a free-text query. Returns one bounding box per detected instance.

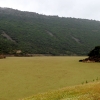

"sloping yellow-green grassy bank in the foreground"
[22,82,100,100]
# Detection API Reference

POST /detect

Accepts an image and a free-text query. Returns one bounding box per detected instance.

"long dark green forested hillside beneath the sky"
[0,8,100,55]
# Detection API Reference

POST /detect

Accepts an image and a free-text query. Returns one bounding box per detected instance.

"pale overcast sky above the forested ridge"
[0,0,100,21]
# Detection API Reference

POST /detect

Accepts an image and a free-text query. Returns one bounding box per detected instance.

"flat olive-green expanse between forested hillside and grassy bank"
[0,57,100,100]
